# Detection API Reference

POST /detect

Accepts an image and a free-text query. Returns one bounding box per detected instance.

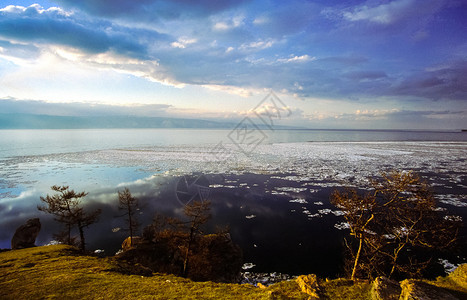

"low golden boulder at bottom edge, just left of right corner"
[399,279,459,300]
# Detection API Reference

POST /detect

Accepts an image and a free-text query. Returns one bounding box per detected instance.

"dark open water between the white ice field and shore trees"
[0,166,465,276]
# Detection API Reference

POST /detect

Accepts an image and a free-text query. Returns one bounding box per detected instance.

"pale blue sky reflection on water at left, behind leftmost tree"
[0,161,153,248]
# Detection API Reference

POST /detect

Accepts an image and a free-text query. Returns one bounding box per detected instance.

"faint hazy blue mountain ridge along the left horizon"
[0,113,236,129]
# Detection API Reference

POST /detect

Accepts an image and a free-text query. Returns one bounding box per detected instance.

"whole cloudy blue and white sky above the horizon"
[0,0,467,129]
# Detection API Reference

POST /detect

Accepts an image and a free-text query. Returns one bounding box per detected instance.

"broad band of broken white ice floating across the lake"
[0,142,467,207]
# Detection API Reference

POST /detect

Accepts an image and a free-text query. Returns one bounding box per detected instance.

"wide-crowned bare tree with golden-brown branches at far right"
[331,171,460,279]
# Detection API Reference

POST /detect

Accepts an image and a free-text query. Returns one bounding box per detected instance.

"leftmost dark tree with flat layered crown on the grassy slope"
[37,185,101,252]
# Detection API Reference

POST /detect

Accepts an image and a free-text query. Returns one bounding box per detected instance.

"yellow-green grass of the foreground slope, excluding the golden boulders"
[0,245,467,300]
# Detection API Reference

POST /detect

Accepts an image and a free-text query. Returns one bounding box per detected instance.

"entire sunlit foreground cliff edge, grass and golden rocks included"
[0,245,467,299]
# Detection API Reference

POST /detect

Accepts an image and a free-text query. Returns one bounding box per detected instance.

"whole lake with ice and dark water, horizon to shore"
[0,128,467,276]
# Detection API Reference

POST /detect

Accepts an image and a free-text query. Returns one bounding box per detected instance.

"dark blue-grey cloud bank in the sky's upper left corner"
[0,6,164,59]
